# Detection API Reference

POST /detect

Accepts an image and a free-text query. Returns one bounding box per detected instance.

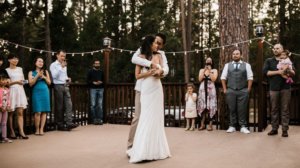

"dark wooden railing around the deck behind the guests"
[24,83,300,133]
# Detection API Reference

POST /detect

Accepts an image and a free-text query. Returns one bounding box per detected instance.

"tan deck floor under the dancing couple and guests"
[0,124,300,168]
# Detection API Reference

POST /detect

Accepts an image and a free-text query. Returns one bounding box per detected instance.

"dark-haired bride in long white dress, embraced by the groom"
[126,36,171,163]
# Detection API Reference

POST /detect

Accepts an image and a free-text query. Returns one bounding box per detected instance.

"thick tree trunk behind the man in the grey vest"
[218,0,249,129]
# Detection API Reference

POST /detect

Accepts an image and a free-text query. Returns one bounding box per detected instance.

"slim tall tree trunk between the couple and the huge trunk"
[180,0,189,83]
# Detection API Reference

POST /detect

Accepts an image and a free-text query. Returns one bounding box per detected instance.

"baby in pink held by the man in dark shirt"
[277,50,294,84]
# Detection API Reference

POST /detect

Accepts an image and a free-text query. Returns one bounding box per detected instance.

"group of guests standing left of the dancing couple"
[0,50,103,143]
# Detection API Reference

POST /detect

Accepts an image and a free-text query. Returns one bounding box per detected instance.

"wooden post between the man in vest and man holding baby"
[257,39,266,132]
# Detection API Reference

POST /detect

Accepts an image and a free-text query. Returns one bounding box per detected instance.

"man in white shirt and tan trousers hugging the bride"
[127,33,169,149]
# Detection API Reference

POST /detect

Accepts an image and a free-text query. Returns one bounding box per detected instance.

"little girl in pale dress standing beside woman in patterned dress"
[185,83,197,131]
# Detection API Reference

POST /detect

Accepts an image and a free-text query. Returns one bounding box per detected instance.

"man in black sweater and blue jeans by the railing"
[87,59,104,125]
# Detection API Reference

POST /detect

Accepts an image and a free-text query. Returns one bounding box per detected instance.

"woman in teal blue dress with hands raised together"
[28,57,51,135]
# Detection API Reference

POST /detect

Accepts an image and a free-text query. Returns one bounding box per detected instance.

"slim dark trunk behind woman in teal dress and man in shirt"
[44,0,52,69]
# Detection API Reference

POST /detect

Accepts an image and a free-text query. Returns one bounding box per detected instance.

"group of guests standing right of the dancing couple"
[185,44,295,137]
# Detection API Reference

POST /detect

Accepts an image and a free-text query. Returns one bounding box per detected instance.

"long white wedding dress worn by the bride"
[127,66,171,163]
